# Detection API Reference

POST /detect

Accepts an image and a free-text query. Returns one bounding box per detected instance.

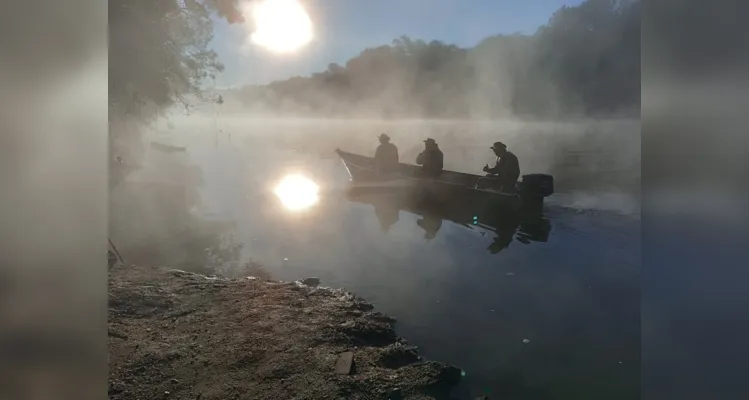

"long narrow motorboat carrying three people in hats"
[336,149,554,211]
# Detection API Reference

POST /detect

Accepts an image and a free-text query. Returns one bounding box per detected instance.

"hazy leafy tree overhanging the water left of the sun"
[109,0,242,186]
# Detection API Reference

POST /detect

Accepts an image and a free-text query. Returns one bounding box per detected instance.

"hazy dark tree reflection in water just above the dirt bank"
[110,157,269,279]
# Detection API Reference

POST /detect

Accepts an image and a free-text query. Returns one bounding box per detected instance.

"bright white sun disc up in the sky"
[245,0,313,53]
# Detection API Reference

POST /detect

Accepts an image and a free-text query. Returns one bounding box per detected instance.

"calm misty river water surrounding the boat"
[134,119,640,399]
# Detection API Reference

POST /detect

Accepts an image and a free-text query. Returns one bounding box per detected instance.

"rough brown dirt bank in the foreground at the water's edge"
[109,266,461,400]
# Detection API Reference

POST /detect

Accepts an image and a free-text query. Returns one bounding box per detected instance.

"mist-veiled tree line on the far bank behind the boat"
[225,0,640,118]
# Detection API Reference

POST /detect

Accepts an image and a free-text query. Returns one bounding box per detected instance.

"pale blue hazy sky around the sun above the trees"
[212,0,582,87]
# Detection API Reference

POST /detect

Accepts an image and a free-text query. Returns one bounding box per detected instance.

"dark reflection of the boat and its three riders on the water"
[346,186,551,254]
